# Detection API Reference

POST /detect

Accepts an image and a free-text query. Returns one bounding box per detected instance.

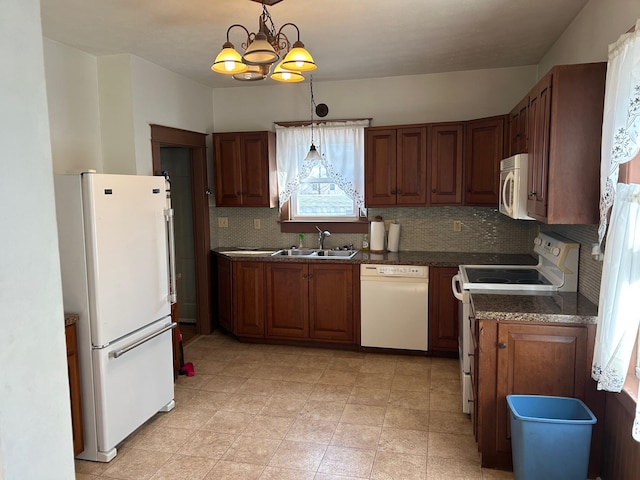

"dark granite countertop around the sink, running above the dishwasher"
[212,248,537,267]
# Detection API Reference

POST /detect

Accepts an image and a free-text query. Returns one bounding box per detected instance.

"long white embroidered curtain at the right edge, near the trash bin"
[592,20,640,442]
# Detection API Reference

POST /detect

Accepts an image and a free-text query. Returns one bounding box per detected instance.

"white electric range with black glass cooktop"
[451,233,580,413]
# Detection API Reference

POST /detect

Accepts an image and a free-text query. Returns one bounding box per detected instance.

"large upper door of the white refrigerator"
[82,173,170,346]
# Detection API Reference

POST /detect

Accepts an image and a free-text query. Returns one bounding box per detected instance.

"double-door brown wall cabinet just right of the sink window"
[364,126,427,207]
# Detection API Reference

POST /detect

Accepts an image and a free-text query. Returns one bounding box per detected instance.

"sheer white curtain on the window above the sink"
[276,120,369,210]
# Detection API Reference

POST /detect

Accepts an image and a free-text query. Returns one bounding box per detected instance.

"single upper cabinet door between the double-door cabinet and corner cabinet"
[429,124,464,205]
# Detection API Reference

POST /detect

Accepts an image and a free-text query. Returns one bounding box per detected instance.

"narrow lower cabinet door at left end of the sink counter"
[233,262,264,337]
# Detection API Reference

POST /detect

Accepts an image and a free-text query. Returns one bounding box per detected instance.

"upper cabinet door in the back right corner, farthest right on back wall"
[464,117,504,207]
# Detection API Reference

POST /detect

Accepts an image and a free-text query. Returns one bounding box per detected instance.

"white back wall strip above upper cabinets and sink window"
[213,65,537,132]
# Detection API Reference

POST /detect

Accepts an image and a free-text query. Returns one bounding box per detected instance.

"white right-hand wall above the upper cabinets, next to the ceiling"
[538,0,640,77]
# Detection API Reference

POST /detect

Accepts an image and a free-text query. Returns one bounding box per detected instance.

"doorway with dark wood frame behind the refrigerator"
[151,125,212,342]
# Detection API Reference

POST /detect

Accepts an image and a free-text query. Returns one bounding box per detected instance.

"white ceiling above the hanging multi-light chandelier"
[41,0,588,87]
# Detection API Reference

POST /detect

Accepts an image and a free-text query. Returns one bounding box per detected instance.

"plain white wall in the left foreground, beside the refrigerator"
[0,0,74,480]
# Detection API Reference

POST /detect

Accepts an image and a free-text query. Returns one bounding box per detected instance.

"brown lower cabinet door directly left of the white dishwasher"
[309,264,354,343]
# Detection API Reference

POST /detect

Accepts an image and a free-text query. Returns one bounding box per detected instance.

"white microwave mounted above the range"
[498,153,534,220]
